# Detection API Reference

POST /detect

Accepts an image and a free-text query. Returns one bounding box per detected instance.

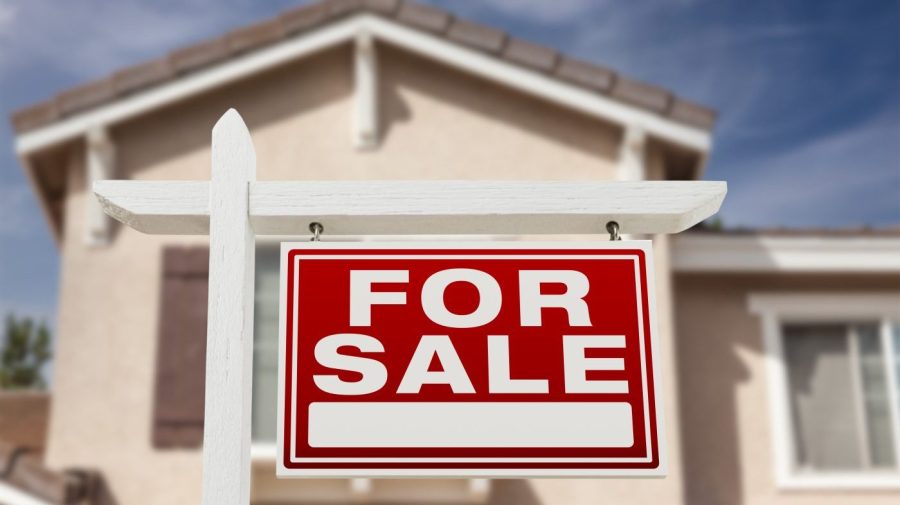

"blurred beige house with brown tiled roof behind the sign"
[7,0,900,505]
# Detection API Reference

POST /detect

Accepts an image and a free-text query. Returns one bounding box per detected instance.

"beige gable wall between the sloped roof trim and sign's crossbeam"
[112,45,621,185]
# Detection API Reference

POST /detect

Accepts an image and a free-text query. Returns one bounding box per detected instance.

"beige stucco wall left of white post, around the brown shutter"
[46,147,202,504]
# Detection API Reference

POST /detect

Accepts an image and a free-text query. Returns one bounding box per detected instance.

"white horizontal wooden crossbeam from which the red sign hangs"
[94,181,726,235]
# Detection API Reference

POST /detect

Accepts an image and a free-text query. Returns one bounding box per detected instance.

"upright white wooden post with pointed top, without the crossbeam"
[203,109,256,505]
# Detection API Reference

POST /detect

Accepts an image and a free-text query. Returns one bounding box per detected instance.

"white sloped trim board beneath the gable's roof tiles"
[16,14,711,157]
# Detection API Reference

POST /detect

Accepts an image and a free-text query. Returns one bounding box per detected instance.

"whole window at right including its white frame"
[750,294,900,488]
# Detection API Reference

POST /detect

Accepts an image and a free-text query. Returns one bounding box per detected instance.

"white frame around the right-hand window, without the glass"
[748,292,900,490]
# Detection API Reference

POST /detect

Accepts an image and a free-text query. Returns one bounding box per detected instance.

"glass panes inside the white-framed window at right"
[781,323,898,472]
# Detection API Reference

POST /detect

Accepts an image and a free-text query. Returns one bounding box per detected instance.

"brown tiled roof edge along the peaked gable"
[11,0,716,134]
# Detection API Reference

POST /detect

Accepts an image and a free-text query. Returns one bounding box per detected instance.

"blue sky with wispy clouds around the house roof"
[0,0,900,323]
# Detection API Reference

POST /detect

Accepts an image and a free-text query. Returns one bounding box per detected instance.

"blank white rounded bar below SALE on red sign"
[309,402,634,447]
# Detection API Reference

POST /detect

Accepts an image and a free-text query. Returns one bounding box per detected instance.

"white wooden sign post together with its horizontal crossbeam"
[94,110,726,505]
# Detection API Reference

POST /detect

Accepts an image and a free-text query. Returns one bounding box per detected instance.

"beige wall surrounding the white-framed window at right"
[674,274,900,505]
